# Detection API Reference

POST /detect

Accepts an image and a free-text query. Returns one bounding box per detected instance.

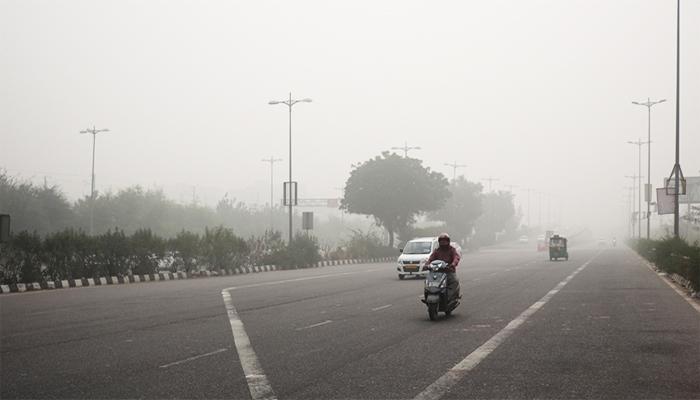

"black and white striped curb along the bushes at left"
[0,257,393,294]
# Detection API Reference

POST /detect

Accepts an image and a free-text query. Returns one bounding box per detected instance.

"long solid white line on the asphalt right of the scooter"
[414,253,600,400]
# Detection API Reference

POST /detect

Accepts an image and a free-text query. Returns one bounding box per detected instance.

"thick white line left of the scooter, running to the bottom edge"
[221,288,277,400]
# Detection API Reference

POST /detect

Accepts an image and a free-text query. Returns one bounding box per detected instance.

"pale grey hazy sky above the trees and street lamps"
[0,0,700,233]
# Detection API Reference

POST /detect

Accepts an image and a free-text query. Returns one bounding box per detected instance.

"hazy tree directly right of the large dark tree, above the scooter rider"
[430,176,484,242]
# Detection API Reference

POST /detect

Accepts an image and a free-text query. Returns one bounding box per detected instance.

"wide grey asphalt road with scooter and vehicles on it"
[0,242,700,399]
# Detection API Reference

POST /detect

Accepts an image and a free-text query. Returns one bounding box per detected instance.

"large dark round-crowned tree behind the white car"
[341,152,450,246]
